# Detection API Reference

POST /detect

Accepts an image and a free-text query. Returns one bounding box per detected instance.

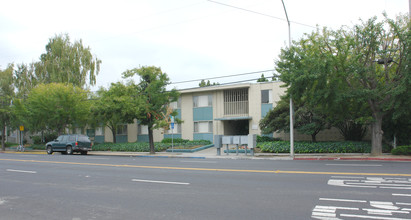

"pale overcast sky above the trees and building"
[0,0,409,90]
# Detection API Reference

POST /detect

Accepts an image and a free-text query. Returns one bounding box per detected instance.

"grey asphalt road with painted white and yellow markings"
[0,153,411,220]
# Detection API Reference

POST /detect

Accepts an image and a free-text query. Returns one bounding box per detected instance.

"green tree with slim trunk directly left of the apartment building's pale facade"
[122,66,179,154]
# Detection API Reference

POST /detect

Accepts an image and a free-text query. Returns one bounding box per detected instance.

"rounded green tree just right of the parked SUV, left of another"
[91,82,142,143]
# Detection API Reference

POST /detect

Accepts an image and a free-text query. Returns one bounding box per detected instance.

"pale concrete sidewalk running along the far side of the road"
[0,147,411,162]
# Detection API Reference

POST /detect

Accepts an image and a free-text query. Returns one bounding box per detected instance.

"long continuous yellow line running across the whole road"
[0,159,411,177]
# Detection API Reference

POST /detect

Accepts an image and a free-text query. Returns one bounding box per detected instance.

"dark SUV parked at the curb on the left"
[46,134,92,155]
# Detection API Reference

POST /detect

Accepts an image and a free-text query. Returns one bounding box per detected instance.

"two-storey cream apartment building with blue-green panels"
[87,81,341,143]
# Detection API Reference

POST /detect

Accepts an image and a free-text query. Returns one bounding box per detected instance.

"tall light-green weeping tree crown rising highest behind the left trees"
[35,34,101,88]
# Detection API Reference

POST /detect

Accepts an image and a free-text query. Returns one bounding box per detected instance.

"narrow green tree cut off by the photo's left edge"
[0,64,14,151]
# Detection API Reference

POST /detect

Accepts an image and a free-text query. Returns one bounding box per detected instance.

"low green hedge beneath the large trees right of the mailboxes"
[257,141,391,153]
